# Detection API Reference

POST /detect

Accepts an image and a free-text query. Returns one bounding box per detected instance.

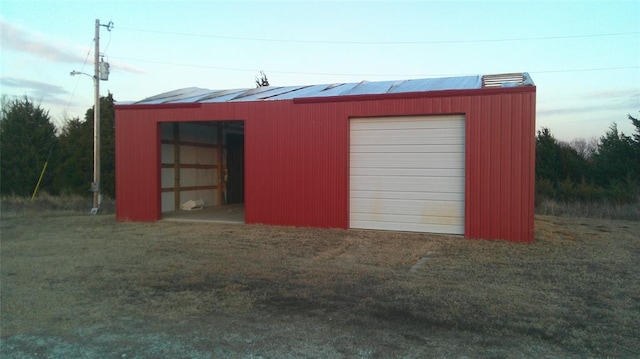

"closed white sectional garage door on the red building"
[349,115,465,234]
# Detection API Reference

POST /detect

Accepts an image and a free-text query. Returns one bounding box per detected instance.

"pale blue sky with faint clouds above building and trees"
[0,0,640,141]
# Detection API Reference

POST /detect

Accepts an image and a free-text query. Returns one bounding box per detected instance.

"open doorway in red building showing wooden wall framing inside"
[160,121,244,223]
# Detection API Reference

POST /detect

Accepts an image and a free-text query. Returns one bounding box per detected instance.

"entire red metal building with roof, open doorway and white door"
[116,73,536,242]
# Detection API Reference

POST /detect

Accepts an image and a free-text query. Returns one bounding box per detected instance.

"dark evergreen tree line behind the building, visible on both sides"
[0,94,640,207]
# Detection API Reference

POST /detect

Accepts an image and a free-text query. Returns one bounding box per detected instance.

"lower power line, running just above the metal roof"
[111,56,640,77]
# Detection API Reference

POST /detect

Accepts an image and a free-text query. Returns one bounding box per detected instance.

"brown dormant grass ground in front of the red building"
[0,211,640,358]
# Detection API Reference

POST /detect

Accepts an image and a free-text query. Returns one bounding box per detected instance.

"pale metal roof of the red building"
[132,72,533,105]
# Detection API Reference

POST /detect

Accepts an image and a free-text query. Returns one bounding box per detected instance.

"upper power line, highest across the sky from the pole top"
[119,27,640,45]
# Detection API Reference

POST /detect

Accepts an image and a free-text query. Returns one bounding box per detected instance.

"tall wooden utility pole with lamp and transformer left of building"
[71,19,113,214]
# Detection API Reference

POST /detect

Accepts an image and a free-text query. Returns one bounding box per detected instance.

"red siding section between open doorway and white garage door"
[245,101,347,228]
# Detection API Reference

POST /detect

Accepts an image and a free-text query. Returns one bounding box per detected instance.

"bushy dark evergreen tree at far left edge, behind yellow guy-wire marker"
[0,96,57,196]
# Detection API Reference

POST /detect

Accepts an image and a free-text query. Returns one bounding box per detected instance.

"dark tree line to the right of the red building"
[536,115,640,204]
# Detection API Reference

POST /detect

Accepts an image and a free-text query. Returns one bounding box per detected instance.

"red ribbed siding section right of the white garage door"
[466,92,535,241]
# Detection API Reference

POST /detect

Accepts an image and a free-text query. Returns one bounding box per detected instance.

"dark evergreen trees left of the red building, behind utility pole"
[0,93,115,198]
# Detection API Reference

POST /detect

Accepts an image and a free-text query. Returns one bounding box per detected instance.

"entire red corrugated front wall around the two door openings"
[116,87,535,241]
